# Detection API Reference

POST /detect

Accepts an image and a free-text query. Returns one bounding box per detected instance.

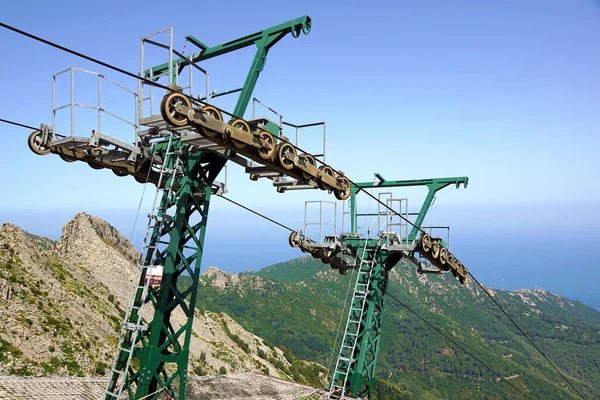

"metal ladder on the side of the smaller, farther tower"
[328,234,383,399]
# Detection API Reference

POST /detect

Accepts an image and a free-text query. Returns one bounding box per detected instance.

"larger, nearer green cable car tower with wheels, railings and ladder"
[28,16,350,400]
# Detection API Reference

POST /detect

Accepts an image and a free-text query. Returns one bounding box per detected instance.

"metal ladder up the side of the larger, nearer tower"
[104,133,181,399]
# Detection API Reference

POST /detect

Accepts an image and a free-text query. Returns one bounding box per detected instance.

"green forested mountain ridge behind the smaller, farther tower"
[198,257,600,399]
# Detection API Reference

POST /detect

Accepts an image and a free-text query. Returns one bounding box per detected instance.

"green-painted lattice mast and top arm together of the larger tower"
[106,16,311,400]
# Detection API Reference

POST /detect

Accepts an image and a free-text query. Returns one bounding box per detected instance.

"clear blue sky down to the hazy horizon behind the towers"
[0,0,600,307]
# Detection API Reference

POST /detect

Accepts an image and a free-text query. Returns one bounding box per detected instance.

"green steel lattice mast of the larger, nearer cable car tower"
[106,148,225,399]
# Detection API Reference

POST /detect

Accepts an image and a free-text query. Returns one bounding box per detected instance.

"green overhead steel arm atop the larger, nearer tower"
[144,15,312,118]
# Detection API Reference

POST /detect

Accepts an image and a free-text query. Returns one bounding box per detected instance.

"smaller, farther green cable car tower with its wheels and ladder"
[289,174,469,399]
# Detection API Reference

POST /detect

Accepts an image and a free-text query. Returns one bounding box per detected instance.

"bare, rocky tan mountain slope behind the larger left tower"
[0,213,325,385]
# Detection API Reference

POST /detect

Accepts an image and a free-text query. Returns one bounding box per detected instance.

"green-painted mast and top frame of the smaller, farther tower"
[332,174,468,398]
